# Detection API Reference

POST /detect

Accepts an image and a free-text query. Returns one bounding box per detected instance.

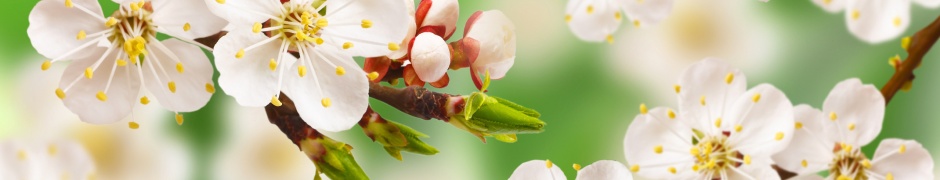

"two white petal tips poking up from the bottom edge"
[509,160,633,180]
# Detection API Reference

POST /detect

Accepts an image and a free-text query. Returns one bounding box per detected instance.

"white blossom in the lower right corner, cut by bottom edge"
[774,78,934,179]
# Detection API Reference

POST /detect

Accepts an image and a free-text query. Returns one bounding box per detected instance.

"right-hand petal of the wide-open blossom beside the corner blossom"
[724,84,795,158]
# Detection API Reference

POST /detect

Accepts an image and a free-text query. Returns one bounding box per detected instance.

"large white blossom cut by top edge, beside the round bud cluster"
[211,0,410,131]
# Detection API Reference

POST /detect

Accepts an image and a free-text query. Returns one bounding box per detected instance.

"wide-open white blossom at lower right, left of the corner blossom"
[624,59,793,179]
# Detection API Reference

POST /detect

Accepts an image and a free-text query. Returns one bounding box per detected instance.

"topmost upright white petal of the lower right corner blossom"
[823,78,885,147]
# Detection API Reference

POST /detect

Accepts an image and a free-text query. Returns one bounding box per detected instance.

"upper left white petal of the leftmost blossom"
[26,0,108,60]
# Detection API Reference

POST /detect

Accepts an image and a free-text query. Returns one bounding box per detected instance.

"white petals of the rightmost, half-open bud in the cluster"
[466,10,516,79]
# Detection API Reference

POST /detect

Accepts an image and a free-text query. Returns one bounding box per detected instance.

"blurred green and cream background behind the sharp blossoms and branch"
[0,0,940,179]
